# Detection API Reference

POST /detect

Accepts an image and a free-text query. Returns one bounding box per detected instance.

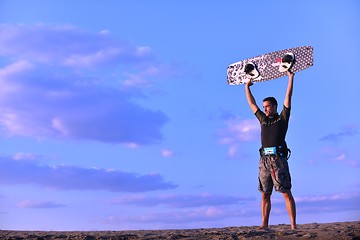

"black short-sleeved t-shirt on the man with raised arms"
[255,106,290,149]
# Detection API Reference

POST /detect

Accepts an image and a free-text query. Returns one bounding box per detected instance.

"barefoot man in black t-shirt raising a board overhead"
[245,71,296,229]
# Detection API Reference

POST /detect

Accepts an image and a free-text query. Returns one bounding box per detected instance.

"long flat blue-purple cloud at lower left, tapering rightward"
[0,155,177,192]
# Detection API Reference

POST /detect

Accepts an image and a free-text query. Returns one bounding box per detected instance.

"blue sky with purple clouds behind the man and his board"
[0,0,360,230]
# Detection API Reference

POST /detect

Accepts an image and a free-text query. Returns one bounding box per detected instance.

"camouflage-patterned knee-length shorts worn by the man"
[259,156,291,194]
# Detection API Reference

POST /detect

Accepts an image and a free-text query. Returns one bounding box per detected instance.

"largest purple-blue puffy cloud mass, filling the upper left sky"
[0,24,176,145]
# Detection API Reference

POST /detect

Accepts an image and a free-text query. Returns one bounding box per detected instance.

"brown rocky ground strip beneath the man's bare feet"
[0,221,360,240]
